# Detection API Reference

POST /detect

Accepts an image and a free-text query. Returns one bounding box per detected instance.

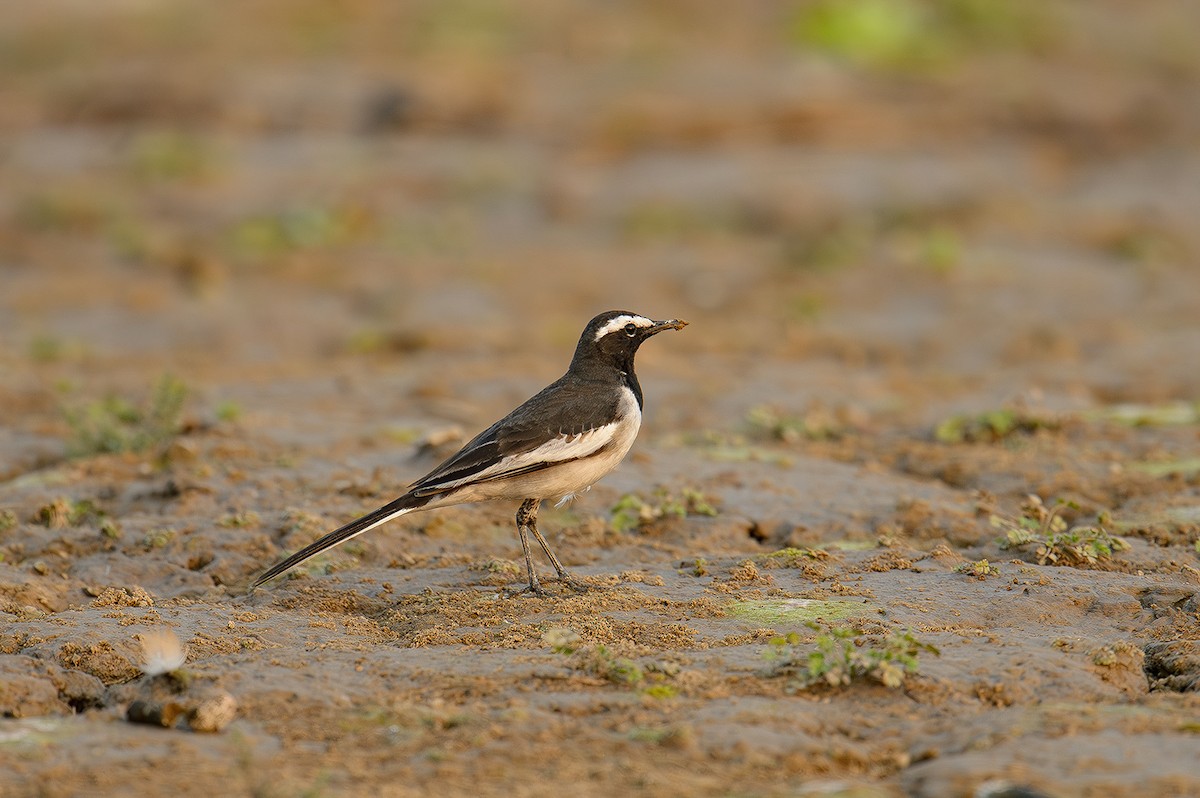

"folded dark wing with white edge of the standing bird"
[409,379,619,496]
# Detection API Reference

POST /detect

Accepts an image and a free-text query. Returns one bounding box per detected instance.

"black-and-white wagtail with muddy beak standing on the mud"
[251,311,688,595]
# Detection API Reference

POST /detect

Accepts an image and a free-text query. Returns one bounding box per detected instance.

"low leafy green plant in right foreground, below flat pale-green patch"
[763,623,940,689]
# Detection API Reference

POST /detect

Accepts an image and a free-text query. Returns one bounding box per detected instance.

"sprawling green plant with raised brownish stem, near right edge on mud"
[990,494,1129,566]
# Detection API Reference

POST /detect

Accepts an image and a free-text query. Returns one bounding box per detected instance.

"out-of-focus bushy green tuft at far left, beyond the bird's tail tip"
[64,374,187,457]
